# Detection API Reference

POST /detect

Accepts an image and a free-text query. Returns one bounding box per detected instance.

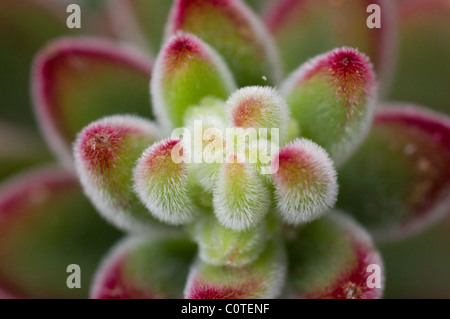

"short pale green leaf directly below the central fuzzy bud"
[194,215,267,267]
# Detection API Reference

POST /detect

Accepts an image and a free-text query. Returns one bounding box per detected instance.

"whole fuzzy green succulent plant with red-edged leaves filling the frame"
[0,0,450,299]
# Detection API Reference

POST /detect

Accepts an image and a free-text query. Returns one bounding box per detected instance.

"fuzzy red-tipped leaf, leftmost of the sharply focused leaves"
[74,115,168,232]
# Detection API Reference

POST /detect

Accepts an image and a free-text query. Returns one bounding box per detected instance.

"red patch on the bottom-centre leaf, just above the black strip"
[187,279,258,299]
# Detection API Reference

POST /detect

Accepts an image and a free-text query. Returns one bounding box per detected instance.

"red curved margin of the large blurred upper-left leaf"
[32,38,152,164]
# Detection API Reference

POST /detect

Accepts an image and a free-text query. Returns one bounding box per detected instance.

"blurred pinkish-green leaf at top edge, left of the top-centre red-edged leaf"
[108,0,173,54]
